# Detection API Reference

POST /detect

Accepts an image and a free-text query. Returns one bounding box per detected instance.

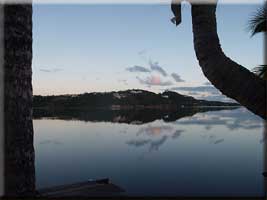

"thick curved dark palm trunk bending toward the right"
[192,3,266,119]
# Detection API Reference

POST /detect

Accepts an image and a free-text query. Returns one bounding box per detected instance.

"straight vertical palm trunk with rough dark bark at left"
[4,4,35,196]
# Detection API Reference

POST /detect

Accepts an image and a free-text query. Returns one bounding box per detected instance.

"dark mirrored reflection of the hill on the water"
[33,106,240,124]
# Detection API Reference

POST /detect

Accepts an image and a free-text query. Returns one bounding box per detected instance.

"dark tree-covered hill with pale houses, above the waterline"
[33,89,240,110]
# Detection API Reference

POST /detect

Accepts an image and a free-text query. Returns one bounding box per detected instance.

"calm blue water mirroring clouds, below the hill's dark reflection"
[34,108,264,196]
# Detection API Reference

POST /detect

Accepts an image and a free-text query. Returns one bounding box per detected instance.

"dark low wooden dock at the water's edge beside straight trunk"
[37,179,125,198]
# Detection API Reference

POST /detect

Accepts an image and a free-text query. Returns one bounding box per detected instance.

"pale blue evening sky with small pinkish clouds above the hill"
[32,1,263,101]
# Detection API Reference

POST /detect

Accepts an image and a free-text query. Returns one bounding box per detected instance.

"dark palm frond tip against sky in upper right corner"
[248,3,267,36]
